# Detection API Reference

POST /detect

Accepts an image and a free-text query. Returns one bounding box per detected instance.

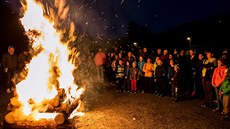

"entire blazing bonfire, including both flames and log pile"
[5,0,84,126]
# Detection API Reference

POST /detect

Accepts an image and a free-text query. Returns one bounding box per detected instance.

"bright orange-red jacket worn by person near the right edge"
[212,66,226,87]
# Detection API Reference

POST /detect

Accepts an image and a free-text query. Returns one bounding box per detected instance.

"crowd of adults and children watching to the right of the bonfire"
[94,47,230,118]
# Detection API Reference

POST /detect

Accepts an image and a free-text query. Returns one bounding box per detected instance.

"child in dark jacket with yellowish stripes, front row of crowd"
[116,59,125,92]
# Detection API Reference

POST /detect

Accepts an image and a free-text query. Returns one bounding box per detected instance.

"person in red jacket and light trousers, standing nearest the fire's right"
[94,48,106,82]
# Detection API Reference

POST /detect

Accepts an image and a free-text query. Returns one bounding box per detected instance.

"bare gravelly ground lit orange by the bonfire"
[0,84,230,129]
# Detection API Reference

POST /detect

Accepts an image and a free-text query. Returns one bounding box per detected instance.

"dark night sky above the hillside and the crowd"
[6,0,230,37]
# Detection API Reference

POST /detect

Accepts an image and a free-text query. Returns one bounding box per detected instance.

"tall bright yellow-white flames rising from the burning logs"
[6,0,84,121]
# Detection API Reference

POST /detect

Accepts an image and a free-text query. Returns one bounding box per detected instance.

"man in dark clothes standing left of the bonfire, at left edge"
[2,46,17,93]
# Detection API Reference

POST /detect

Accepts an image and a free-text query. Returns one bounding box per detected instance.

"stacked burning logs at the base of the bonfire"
[5,89,81,128]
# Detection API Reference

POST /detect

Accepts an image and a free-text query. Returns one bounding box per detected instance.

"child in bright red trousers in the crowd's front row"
[130,61,139,93]
